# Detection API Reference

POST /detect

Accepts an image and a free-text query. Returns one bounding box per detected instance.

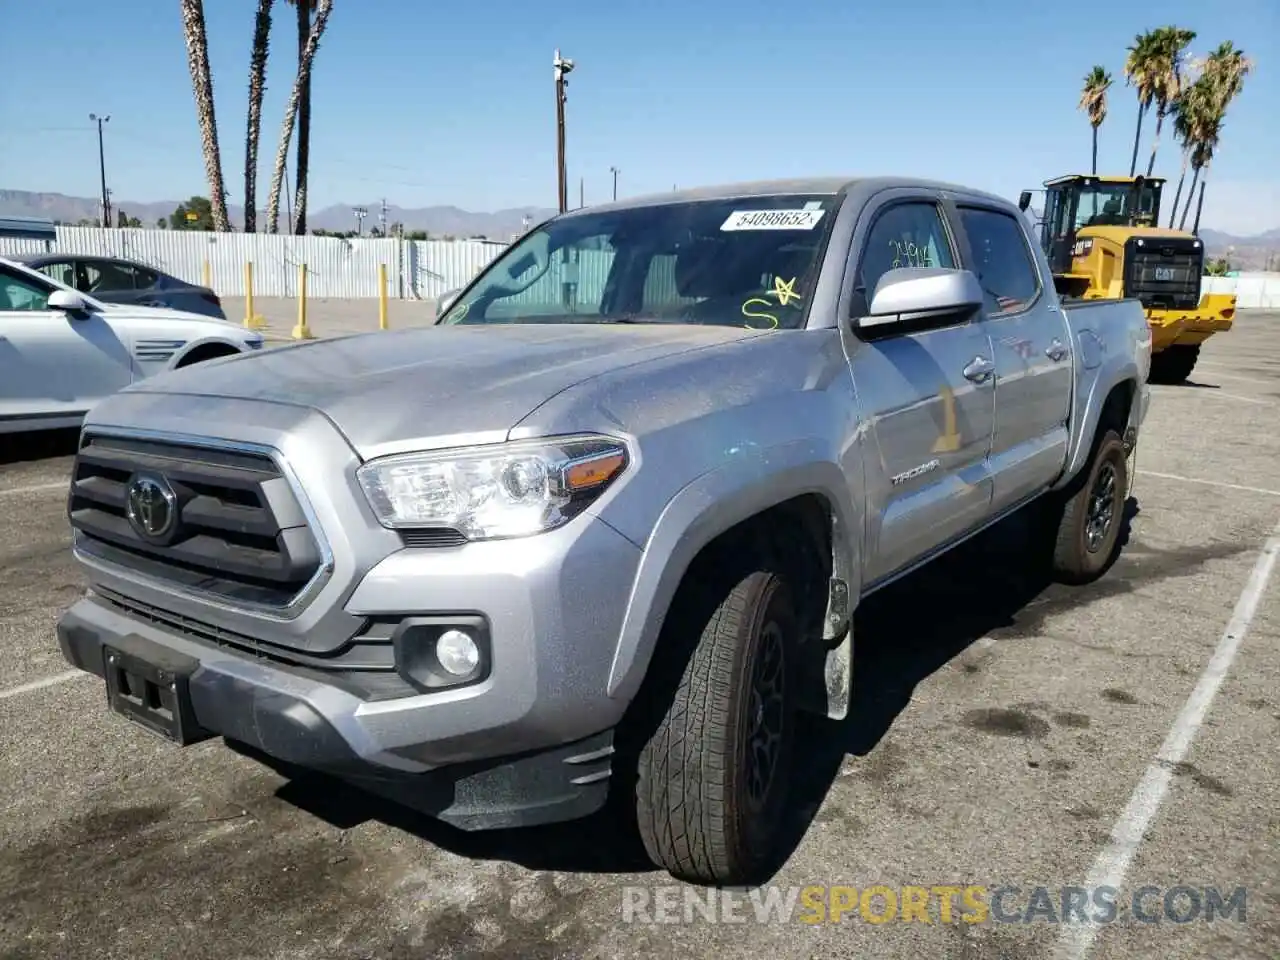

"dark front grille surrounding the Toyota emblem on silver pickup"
[68,434,323,608]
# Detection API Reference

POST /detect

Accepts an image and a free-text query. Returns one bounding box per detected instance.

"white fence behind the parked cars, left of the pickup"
[0,227,506,300]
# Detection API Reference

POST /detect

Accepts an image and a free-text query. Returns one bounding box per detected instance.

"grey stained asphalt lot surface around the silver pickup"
[0,307,1280,960]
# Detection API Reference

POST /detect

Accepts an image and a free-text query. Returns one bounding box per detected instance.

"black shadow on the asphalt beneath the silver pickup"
[262,498,1138,882]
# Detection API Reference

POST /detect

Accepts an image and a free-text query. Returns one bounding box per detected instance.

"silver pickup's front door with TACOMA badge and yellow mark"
[850,191,995,586]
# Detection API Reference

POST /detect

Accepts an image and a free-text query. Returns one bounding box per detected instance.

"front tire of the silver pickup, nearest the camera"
[636,570,799,884]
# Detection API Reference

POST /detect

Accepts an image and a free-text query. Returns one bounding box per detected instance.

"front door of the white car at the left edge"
[0,265,133,420]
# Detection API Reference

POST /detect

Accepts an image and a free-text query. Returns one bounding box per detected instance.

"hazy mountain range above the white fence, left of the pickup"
[0,189,556,241]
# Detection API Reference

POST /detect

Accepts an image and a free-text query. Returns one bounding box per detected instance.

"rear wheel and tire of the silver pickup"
[1052,429,1129,584]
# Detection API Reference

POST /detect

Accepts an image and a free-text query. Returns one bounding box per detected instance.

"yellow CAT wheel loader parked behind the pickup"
[1018,174,1235,383]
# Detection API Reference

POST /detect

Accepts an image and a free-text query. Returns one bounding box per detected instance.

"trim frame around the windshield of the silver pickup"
[435,188,847,332]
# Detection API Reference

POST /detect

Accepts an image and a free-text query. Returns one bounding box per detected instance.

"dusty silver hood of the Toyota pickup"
[127,324,762,458]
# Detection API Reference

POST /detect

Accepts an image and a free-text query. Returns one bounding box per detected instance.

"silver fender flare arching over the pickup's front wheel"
[607,439,861,700]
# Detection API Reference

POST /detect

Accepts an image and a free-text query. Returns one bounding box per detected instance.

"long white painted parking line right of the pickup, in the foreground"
[1057,524,1280,960]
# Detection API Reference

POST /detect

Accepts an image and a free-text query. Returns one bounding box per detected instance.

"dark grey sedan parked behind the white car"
[15,253,227,320]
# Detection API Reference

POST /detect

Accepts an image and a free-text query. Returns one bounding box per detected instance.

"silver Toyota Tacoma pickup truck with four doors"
[58,179,1151,883]
